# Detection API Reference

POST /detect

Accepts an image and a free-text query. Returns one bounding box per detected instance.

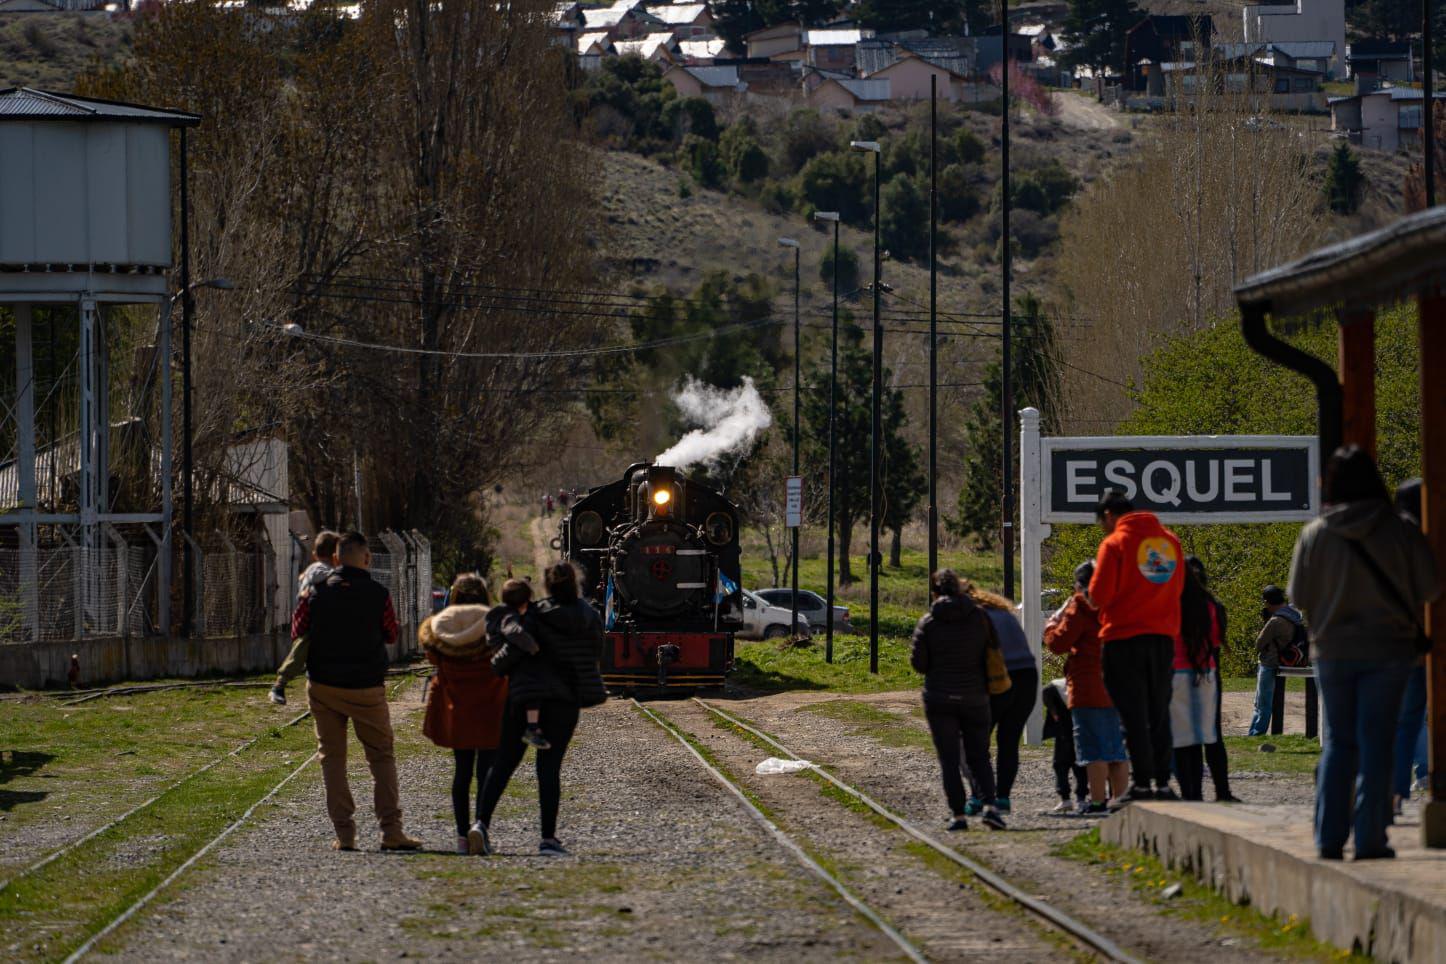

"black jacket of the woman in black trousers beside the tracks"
[910,595,993,707]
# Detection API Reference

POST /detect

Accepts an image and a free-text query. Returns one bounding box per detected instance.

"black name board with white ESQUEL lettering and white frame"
[1041,436,1317,522]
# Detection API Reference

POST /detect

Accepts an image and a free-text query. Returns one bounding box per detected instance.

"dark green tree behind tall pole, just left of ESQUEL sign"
[946,295,1058,549]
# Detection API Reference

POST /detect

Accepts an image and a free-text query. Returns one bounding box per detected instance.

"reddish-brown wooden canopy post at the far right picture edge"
[1419,289,1446,847]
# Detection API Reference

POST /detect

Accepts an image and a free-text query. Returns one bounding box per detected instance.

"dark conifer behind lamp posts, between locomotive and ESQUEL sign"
[804,321,921,585]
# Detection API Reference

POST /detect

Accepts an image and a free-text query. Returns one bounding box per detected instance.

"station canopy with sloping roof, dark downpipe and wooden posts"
[1235,207,1446,847]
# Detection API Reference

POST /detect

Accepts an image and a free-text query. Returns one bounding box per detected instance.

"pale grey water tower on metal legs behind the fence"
[0,87,200,639]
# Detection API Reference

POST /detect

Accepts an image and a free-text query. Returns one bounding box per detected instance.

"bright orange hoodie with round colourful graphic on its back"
[1089,512,1184,643]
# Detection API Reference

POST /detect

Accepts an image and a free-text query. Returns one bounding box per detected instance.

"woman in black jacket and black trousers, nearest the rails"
[910,569,1004,830]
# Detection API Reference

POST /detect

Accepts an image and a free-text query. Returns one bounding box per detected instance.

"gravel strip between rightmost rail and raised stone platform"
[719,694,1312,961]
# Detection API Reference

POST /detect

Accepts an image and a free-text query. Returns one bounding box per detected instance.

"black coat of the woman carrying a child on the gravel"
[492,598,607,707]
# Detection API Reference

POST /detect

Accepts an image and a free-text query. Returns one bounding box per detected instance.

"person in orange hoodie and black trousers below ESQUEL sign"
[1089,489,1184,805]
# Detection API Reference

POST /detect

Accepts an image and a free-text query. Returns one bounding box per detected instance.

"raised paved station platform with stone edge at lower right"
[1100,802,1446,964]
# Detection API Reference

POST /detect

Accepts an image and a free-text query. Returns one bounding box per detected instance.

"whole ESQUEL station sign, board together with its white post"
[1019,408,1320,744]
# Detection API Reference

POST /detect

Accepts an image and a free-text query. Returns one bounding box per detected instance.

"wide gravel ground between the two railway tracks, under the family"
[93,688,897,961]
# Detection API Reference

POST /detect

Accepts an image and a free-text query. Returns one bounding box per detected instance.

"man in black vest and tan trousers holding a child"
[291,532,422,850]
